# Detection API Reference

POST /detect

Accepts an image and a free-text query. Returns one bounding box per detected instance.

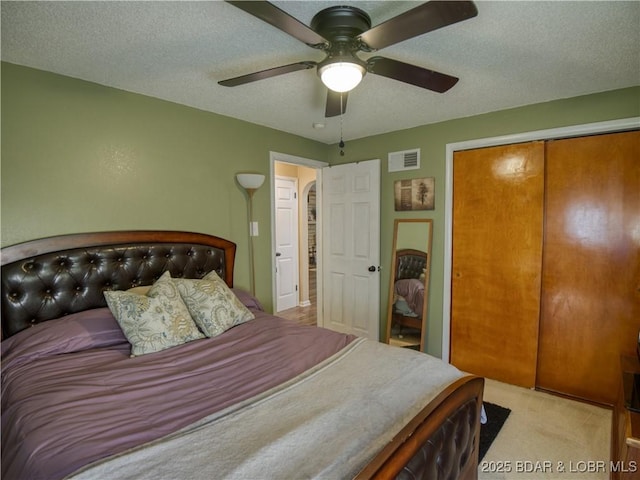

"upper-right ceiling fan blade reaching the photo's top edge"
[358,0,478,50]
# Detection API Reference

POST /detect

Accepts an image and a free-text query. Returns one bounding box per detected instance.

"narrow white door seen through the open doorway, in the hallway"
[275,177,298,312]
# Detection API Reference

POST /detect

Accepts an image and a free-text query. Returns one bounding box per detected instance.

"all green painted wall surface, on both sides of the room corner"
[1,63,640,356]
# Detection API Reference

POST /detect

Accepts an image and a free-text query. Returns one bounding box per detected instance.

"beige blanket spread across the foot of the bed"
[71,339,462,480]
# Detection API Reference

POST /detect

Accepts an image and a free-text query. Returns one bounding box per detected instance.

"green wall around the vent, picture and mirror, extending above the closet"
[328,87,640,356]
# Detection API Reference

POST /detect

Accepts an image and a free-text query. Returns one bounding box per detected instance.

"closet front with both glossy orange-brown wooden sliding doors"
[450,131,640,404]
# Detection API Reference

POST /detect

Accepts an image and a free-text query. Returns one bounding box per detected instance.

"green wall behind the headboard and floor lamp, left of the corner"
[1,63,327,309]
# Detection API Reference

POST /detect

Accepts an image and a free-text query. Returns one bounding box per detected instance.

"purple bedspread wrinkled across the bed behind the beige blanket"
[2,308,355,480]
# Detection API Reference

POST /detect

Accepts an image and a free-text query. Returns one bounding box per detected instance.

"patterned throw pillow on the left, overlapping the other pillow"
[104,272,204,356]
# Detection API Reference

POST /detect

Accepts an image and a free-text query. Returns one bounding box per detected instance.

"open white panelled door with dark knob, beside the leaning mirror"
[319,160,380,341]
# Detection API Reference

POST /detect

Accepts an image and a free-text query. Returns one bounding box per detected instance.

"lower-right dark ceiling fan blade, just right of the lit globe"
[367,57,458,93]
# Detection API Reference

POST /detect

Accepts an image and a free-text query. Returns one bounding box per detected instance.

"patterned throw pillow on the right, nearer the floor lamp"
[173,271,255,337]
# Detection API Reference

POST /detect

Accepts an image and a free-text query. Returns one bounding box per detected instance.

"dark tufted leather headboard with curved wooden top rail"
[1,230,236,338]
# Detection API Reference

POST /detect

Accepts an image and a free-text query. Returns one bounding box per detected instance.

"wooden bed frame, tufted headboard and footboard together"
[1,231,484,480]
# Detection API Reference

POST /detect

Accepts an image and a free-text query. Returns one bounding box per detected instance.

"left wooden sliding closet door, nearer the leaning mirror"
[451,142,544,387]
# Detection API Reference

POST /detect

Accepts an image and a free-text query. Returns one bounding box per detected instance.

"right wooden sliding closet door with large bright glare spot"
[537,131,640,404]
